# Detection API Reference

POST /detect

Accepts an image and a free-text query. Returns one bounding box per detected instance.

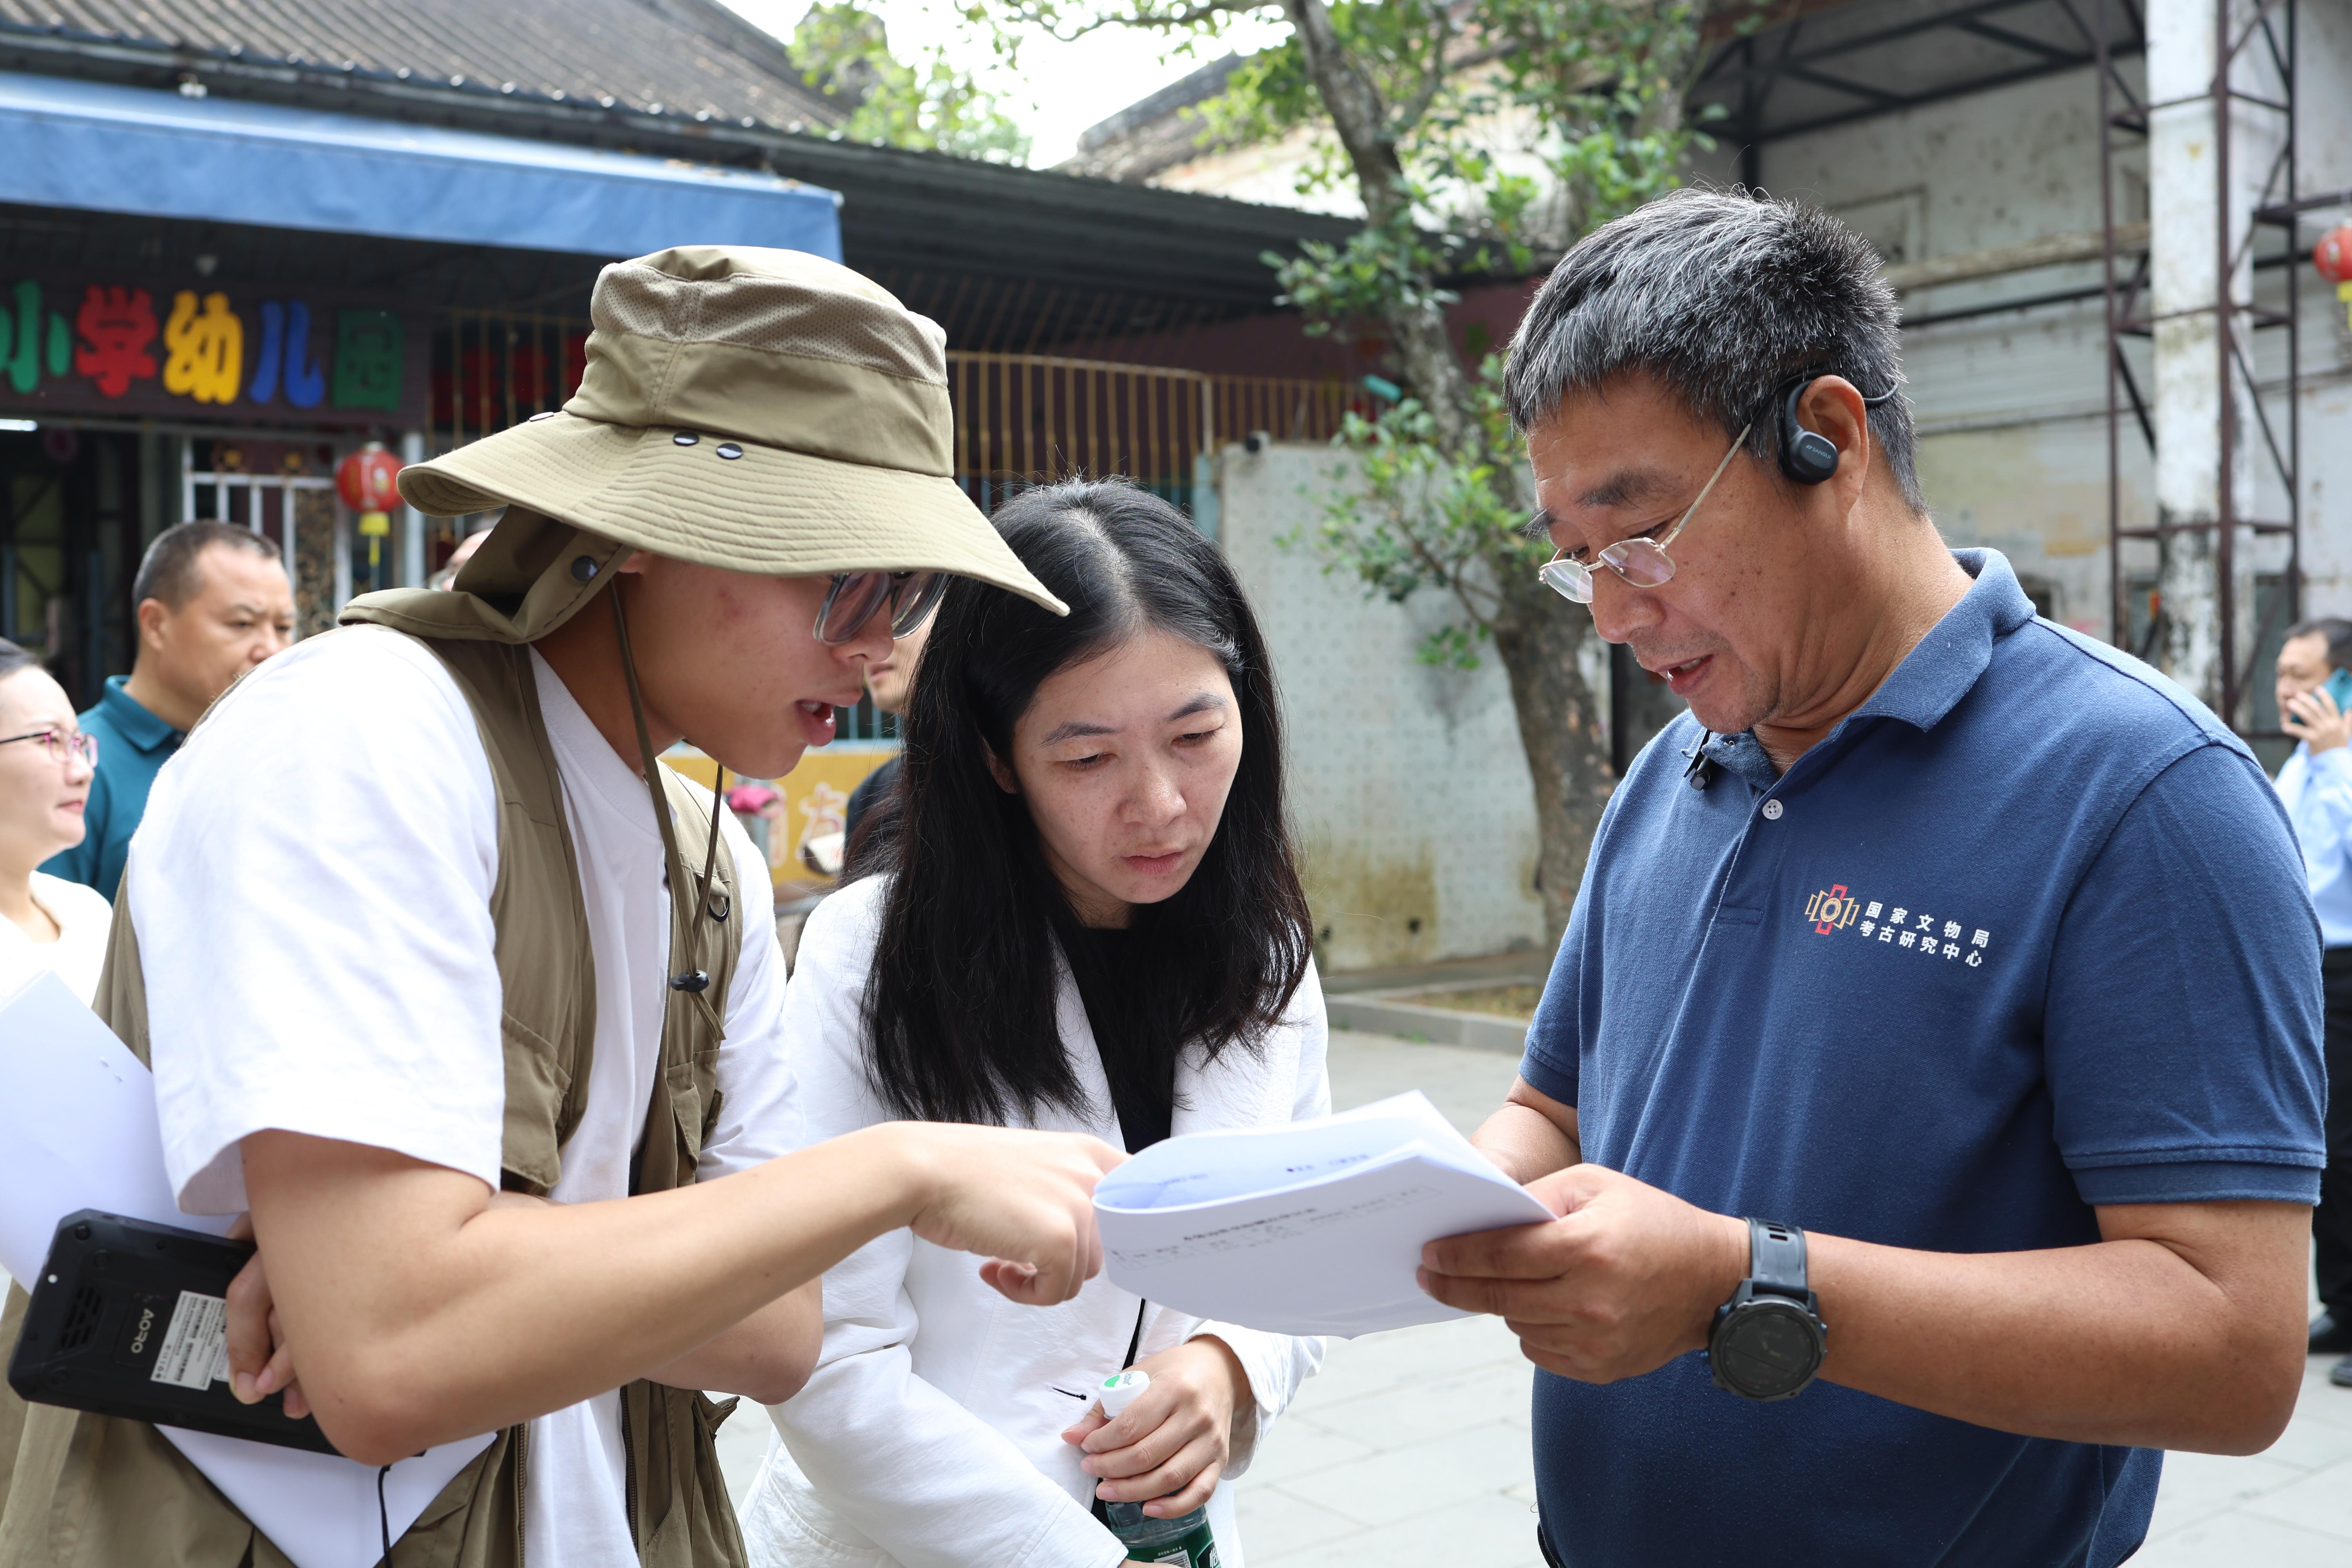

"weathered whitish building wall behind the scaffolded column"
[1700,47,2352,658]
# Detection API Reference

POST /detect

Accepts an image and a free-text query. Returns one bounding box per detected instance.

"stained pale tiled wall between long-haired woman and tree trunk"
[1216,444,1543,971]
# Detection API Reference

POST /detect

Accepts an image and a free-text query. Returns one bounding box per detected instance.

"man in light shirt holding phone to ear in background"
[2279,616,2352,1389]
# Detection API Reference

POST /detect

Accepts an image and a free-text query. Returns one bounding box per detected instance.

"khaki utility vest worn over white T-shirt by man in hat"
[0,576,764,1568]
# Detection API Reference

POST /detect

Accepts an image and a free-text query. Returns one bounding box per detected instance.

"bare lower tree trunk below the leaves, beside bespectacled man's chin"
[1494,588,1616,943]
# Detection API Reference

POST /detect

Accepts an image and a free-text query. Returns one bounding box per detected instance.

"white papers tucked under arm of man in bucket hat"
[0,971,492,1568]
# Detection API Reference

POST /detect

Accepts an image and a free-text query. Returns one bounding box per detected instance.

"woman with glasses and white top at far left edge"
[0,642,113,1002]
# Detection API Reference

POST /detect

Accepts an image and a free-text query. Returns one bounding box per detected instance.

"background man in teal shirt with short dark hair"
[40,522,294,898]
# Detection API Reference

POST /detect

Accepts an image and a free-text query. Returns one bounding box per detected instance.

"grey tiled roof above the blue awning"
[0,0,840,129]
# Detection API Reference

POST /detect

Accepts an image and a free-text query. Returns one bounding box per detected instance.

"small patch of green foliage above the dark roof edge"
[793,0,1030,162]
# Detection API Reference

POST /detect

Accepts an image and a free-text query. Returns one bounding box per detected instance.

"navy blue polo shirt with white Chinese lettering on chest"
[1522,550,2324,1568]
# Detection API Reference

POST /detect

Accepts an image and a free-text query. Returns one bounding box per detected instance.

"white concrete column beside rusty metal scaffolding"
[2147,0,2284,705]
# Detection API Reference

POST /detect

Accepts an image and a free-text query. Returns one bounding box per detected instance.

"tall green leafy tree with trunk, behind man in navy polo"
[964,0,1700,929]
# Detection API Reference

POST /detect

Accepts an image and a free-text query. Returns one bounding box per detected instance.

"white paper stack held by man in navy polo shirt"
[1094,1093,1552,1338]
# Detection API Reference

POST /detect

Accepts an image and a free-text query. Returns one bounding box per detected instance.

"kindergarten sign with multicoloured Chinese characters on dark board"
[0,278,426,428]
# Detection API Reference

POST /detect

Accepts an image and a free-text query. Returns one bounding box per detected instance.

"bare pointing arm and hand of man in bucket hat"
[242,1124,1122,1465]
